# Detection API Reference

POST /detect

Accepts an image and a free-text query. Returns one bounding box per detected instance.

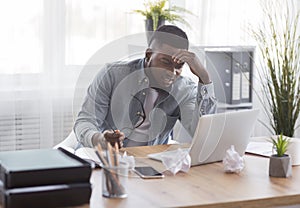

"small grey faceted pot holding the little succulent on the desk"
[269,154,292,178]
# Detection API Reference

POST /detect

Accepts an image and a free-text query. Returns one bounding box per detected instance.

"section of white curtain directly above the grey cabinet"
[186,0,260,46]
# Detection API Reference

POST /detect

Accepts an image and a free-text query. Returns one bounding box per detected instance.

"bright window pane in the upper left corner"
[0,0,43,74]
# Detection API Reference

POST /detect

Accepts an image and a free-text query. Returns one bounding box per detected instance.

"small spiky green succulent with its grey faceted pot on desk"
[269,134,292,177]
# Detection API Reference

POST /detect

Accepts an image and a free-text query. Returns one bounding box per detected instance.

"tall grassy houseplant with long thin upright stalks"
[252,0,300,137]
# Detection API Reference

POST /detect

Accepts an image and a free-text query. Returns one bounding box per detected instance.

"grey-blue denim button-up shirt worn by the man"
[74,59,217,147]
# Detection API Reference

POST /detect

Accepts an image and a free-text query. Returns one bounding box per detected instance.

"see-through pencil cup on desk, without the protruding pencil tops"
[102,163,128,198]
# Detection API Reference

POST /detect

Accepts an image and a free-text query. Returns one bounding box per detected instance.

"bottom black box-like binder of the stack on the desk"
[0,180,92,208]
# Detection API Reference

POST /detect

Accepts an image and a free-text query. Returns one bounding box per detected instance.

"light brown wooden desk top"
[84,145,300,208]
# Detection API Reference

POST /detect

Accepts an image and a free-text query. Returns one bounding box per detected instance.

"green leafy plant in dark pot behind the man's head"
[134,0,192,31]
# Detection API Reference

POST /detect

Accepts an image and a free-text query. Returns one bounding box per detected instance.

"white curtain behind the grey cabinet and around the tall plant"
[186,0,300,136]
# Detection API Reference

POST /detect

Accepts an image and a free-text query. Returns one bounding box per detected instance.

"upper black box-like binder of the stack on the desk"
[0,148,92,189]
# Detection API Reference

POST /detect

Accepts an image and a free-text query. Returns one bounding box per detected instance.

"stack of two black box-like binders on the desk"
[0,148,92,208]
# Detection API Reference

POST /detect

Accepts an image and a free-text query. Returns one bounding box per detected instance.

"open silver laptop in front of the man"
[148,109,259,166]
